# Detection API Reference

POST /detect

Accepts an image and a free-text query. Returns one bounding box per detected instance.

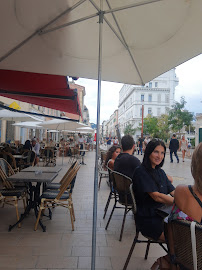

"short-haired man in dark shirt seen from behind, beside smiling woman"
[114,135,140,179]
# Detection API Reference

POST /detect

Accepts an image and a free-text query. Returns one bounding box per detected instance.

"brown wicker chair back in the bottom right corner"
[164,220,202,270]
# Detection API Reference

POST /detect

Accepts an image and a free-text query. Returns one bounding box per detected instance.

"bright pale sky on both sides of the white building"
[76,55,202,123]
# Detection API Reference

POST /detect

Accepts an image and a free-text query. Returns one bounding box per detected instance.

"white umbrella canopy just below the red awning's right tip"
[40,119,86,130]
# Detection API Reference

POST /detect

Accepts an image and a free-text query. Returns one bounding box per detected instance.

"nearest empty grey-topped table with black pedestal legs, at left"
[7,172,58,232]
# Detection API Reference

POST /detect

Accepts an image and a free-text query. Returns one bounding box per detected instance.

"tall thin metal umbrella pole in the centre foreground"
[91,4,104,270]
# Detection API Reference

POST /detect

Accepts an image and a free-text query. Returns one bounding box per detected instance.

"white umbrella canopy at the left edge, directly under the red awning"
[0,110,41,121]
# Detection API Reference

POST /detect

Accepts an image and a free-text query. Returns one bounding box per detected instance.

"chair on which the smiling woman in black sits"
[123,184,168,270]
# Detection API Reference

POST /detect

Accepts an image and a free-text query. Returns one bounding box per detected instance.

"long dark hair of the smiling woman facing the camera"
[142,139,166,170]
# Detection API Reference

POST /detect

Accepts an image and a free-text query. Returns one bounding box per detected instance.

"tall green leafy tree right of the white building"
[168,97,193,132]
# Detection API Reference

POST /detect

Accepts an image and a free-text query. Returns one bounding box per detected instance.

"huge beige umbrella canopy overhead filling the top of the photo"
[0,0,202,84]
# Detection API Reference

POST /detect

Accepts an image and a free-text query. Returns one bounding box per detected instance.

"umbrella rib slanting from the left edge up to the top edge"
[0,0,86,62]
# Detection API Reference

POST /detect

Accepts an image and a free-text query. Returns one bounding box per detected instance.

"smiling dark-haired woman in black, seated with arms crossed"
[133,139,175,240]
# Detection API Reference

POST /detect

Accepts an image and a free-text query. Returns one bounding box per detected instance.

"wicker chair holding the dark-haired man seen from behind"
[105,171,133,241]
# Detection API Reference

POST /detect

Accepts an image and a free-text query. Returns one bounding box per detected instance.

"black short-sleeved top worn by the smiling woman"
[133,165,175,217]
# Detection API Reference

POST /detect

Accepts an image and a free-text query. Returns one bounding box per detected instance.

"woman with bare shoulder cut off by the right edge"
[169,143,202,224]
